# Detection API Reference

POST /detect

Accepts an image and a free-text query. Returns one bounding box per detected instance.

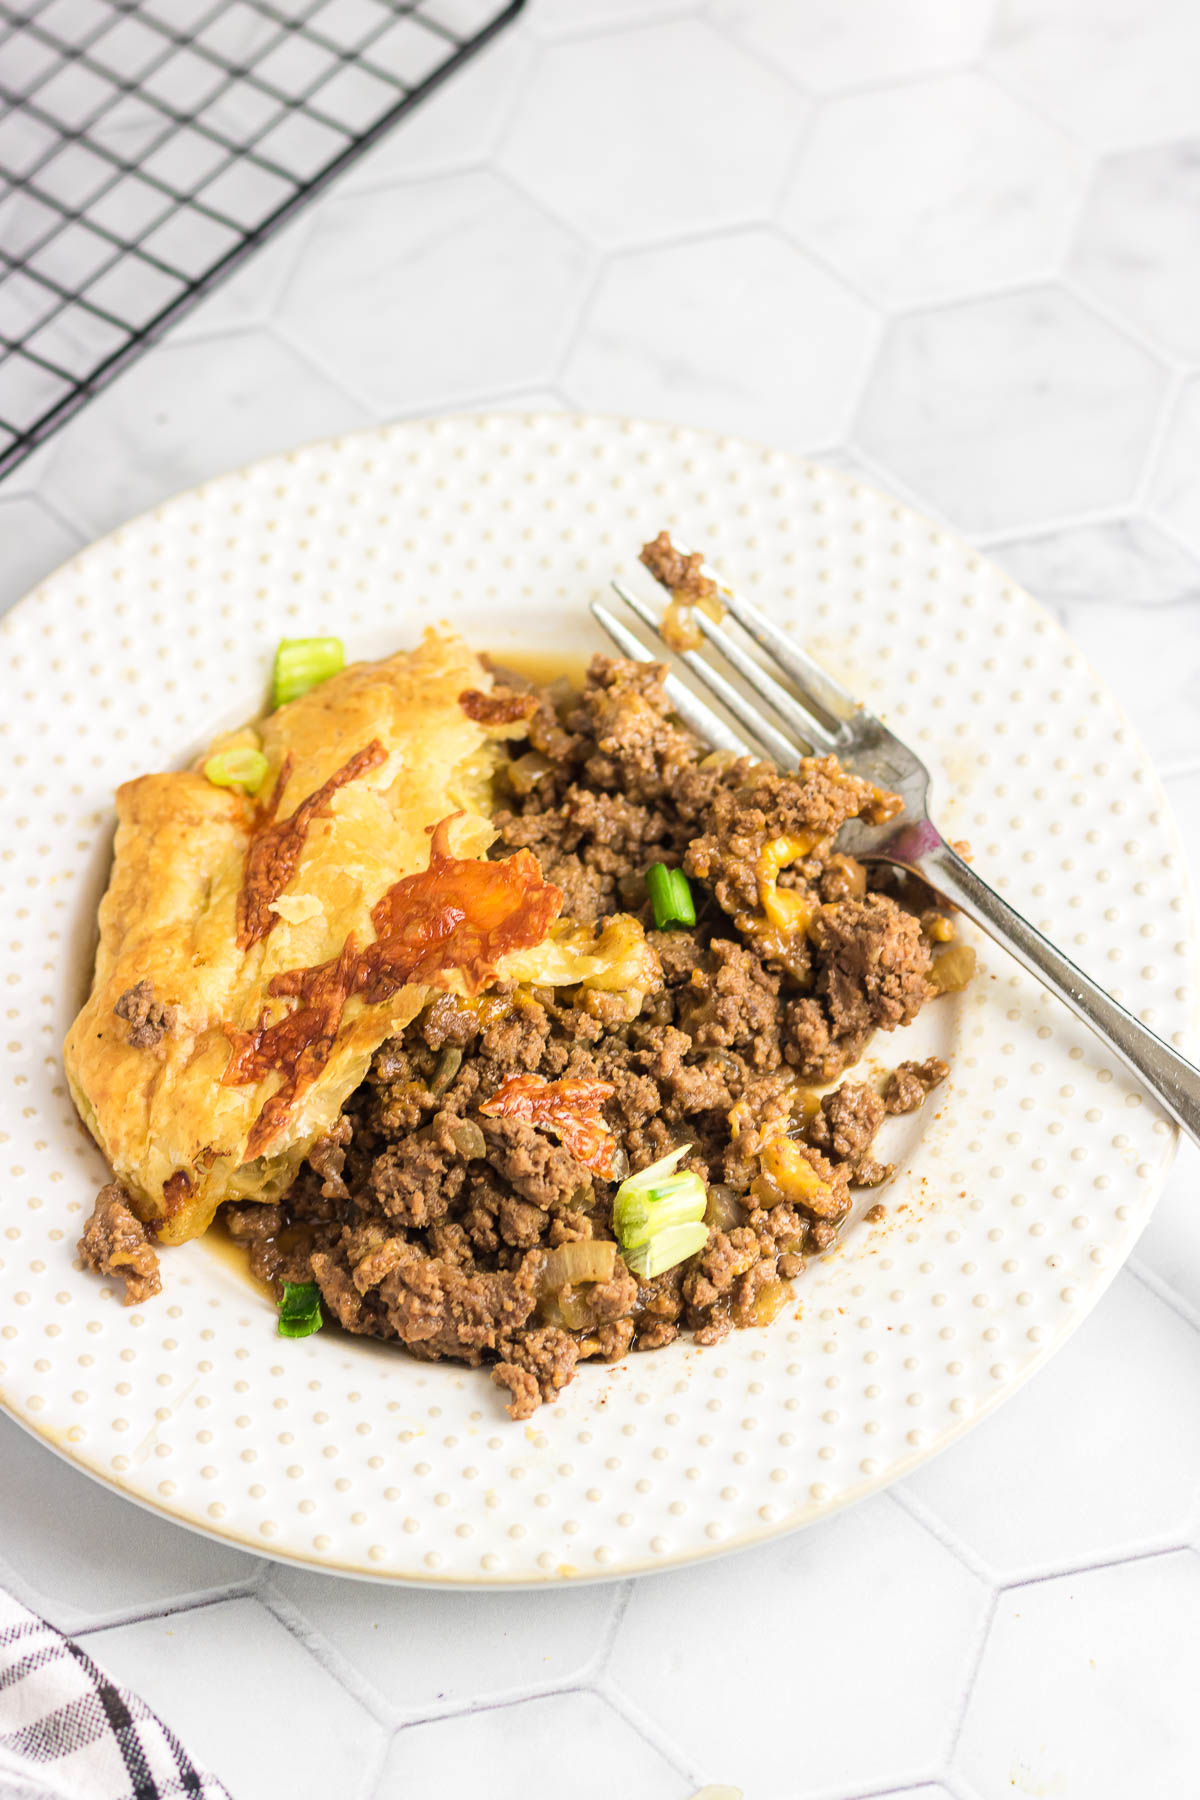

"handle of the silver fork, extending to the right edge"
[910,833,1200,1143]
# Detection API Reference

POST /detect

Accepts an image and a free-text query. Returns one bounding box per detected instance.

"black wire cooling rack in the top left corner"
[0,0,524,475]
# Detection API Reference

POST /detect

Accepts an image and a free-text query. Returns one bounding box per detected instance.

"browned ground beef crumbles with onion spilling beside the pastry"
[81,612,946,1418]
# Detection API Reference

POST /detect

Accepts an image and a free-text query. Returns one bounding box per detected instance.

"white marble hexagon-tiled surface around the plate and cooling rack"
[0,0,1200,1800]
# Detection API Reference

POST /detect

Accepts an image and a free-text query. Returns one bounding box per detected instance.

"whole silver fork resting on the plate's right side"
[592,565,1200,1143]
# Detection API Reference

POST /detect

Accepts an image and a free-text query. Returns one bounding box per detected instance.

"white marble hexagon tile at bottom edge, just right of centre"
[610,1494,990,1795]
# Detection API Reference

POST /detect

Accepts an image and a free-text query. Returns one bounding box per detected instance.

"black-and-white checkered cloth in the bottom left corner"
[0,1588,228,1800]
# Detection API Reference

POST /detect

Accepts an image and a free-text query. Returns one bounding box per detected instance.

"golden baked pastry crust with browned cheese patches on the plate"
[65,632,564,1244]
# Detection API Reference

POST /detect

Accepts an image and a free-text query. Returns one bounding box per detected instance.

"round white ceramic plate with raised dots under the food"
[0,416,1195,1584]
